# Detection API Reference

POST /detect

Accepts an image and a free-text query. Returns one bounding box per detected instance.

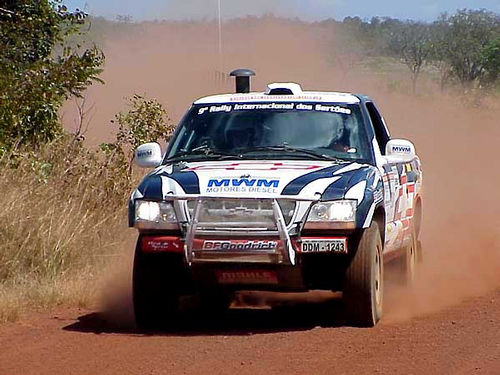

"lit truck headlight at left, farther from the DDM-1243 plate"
[135,200,178,229]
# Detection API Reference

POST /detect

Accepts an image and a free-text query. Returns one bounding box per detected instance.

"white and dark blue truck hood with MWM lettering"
[133,160,379,200]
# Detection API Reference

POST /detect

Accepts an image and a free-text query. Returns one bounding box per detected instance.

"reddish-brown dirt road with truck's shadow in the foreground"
[0,290,500,375]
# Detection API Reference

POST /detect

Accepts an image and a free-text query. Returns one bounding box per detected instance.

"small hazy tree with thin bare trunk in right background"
[389,21,432,93]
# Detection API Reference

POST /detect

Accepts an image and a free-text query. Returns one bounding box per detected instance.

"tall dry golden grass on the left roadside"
[0,139,136,322]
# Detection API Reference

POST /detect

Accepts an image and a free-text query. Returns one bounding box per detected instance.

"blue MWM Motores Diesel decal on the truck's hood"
[207,178,280,193]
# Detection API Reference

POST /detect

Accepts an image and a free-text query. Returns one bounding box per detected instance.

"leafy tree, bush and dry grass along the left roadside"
[0,0,172,322]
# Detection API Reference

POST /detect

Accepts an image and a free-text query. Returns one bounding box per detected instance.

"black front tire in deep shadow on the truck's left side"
[132,237,187,329]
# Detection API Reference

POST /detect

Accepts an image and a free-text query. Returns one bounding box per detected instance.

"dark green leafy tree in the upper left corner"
[0,0,104,149]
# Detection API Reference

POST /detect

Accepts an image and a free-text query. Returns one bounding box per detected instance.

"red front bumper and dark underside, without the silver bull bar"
[139,232,359,292]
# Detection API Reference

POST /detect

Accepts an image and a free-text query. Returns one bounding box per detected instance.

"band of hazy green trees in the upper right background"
[341,9,500,90]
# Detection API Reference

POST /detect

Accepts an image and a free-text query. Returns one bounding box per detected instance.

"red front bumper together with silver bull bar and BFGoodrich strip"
[136,196,358,291]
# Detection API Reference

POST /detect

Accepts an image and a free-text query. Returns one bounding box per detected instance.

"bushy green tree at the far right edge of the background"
[439,9,500,89]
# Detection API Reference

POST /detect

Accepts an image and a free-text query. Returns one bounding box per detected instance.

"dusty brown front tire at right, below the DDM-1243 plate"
[344,221,384,327]
